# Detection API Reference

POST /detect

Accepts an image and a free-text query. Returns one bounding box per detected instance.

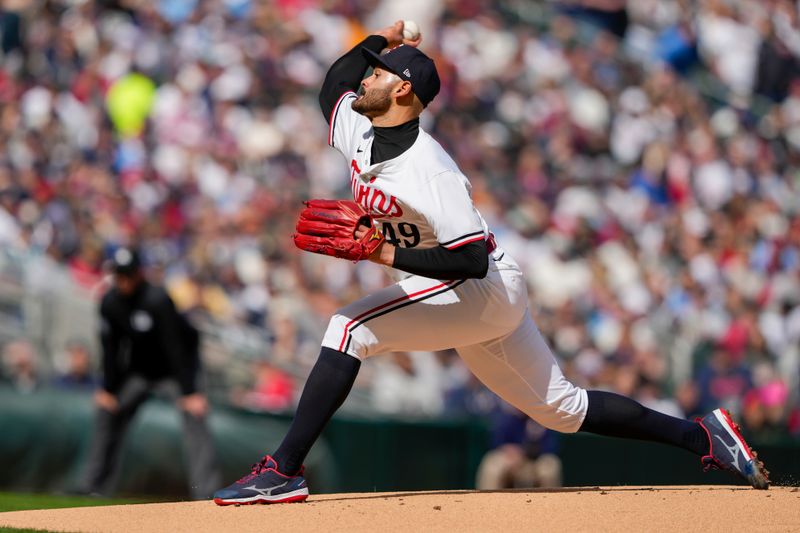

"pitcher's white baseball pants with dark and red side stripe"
[322,249,587,433]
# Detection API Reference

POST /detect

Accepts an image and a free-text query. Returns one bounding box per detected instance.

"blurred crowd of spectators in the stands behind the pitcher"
[0,0,800,435]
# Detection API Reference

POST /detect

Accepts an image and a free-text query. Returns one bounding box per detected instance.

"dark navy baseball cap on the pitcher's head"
[361,44,441,106]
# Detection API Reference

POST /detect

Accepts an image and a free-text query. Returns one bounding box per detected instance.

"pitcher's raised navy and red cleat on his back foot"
[696,409,769,489]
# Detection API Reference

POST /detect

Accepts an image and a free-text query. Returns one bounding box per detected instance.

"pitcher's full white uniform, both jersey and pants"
[322,92,588,432]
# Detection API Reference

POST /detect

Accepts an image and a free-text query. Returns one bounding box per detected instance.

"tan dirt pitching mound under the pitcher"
[0,486,800,533]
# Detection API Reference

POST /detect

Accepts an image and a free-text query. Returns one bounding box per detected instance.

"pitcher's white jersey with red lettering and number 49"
[328,92,489,254]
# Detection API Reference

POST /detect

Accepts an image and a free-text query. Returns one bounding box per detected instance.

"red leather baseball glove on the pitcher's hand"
[294,200,383,261]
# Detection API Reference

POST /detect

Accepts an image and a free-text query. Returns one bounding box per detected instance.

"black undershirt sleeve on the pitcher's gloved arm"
[392,241,489,279]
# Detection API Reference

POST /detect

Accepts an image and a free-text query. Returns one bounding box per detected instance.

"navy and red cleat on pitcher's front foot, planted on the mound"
[214,455,308,505]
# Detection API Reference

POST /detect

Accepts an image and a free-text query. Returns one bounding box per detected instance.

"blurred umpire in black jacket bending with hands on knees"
[84,248,220,499]
